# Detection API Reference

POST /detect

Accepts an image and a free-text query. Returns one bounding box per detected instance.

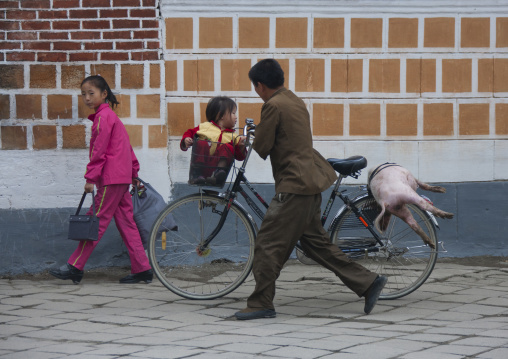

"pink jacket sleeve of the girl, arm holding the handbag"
[85,114,114,184]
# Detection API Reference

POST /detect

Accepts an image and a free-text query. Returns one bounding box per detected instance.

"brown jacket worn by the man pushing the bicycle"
[253,88,337,195]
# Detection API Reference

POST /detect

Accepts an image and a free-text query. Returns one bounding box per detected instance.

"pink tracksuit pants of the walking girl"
[68,184,151,273]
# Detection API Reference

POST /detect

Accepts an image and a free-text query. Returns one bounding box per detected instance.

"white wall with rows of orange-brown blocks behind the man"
[162,1,508,186]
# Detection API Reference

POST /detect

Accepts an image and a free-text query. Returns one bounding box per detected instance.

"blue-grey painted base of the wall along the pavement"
[0,181,508,275]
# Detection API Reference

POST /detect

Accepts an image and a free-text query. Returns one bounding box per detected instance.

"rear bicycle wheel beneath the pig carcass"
[331,194,438,299]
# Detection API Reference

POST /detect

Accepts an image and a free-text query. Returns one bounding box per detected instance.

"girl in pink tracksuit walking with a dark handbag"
[49,75,153,284]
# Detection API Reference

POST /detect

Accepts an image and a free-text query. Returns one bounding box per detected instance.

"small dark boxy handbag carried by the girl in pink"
[67,191,99,241]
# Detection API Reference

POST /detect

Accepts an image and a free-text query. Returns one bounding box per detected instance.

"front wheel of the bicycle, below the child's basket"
[148,193,255,299]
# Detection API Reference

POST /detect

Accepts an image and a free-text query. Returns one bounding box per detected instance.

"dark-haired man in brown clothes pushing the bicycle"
[235,59,387,320]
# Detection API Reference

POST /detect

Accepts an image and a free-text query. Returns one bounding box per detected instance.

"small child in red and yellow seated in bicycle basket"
[180,96,246,185]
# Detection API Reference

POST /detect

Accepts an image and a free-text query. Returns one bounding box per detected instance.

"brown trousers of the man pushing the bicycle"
[247,193,377,309]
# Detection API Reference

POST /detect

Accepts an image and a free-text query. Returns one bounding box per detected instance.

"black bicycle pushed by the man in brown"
[148,119,444,299]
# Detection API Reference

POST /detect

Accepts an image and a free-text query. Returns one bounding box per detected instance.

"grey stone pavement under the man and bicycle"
[0,261,508,359]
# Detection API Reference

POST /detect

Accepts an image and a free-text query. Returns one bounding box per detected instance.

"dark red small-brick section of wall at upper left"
[0,0,159,62]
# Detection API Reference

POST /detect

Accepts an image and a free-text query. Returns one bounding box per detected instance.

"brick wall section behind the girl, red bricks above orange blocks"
[0,0,166,150]
